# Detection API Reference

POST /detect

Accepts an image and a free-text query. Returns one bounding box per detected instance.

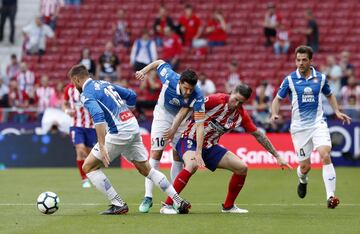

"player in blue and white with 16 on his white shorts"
[135,60,205,213]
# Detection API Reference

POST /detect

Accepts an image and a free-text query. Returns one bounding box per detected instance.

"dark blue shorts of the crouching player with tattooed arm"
[176,138,228,171]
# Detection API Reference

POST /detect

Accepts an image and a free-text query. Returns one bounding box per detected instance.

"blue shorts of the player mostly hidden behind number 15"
[70,127,97,148]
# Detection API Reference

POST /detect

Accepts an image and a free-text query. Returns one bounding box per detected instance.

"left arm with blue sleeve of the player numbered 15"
[81,96,110,167]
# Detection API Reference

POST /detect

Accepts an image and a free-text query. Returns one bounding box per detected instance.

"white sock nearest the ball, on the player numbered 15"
[86,169,124,206]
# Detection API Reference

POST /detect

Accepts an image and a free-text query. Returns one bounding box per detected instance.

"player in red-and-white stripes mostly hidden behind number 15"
[63,84,96,188]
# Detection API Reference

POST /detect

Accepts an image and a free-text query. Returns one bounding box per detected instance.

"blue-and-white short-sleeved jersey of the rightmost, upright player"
[277,67,331,133]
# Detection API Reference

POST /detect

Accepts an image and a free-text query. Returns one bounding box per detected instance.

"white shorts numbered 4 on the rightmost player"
[291,121,331,161]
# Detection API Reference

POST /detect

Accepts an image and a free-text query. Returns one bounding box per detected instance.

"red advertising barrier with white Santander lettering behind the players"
[121,133,321,168]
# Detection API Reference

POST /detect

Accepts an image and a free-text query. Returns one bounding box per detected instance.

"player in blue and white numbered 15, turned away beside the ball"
[69,65,191,215]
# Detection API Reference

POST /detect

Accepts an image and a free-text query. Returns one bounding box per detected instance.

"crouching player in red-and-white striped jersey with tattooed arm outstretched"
[160,84,291,214]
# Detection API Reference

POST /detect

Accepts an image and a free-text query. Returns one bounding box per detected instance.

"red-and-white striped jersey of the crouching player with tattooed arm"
[183,93,256,148]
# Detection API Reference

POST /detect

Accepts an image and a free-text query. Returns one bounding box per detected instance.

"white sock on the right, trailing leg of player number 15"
[147,168,183,205]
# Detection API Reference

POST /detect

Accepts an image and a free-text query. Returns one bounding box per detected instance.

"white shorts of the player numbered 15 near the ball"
[91,133,148,162]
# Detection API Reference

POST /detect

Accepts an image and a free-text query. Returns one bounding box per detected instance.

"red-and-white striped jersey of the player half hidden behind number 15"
[64,84,94,128]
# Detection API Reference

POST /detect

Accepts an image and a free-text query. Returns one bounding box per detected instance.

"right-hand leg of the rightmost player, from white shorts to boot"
[313,123,340,208]
